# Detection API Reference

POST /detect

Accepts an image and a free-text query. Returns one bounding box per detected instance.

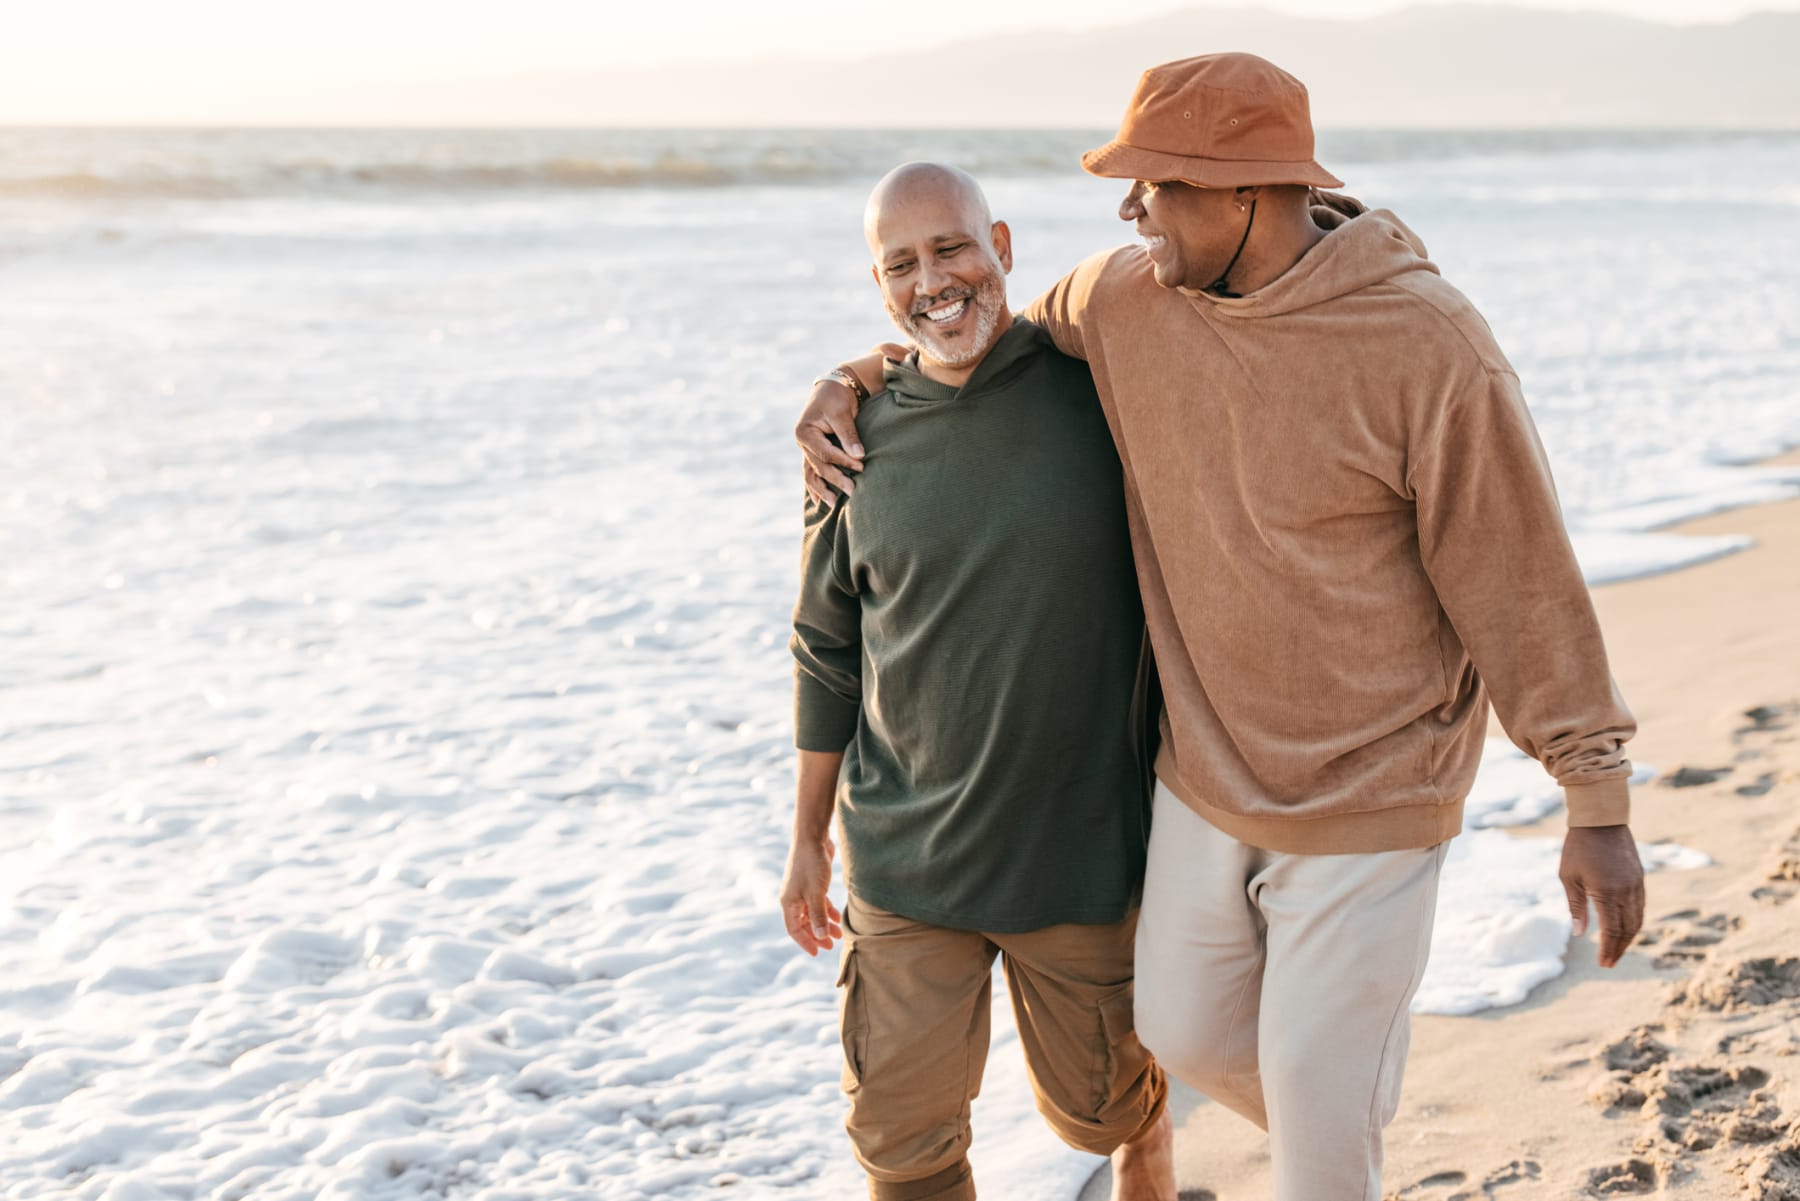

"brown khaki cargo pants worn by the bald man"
[837,895,1166,1201]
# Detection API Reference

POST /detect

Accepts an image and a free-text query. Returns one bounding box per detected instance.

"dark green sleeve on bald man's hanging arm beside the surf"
[788,497,862,753]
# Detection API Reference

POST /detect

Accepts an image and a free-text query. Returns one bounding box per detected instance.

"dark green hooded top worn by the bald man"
[792,321,1148,933]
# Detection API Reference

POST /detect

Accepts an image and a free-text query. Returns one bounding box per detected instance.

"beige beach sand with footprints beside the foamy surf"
[1082,454,1800,1201]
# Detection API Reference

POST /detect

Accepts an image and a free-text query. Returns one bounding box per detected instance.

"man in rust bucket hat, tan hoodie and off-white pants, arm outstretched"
[796,54,1643,1201]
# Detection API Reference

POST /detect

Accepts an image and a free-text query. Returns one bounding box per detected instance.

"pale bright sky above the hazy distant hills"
[0,0,1800,124]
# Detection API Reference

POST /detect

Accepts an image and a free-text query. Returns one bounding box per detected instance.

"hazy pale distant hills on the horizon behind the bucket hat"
[369,5,1800,128]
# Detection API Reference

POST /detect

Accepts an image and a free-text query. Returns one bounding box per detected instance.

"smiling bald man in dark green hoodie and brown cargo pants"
[781,164,1175,1201]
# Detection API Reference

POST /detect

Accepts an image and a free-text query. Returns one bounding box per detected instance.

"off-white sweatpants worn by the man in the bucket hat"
[1138,783,1445,1201]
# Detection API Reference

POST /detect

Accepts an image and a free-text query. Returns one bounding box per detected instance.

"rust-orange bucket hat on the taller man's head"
[1082,54,1343,187]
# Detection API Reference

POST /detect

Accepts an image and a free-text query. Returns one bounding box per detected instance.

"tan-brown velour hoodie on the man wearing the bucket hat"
[1026,201,1636,853]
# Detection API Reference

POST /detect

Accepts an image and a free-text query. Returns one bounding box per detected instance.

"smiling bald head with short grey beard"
[864,164,1012,378]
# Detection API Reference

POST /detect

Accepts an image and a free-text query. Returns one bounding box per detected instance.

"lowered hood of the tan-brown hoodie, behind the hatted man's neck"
[1181,205,1438,317]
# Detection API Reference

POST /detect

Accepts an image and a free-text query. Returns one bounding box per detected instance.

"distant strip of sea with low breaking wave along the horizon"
[0,128,1795,202]
